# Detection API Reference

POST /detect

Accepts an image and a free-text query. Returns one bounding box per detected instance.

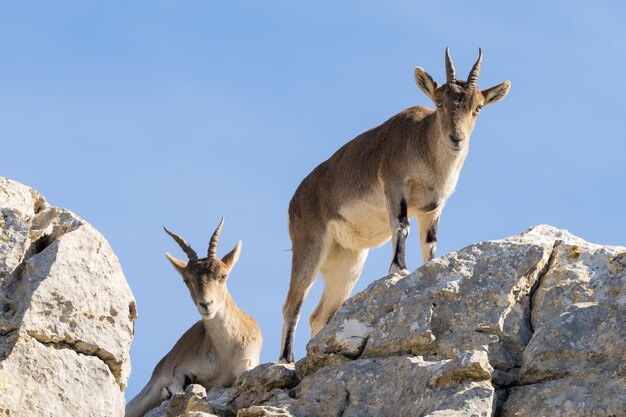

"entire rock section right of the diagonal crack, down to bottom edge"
[503,234,626,417]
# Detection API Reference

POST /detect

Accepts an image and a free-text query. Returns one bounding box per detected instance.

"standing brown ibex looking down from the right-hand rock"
[280,49,511,362]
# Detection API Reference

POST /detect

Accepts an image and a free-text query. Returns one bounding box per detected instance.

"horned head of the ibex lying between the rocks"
[163,218,241,320]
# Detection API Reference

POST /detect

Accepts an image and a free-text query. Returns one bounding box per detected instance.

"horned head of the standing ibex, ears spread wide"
[415,48,511,151]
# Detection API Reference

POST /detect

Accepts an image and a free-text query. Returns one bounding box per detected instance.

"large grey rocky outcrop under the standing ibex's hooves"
[147,226,626,417]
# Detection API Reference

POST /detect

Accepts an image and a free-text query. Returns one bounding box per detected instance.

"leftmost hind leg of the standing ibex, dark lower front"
[279,237,324,363]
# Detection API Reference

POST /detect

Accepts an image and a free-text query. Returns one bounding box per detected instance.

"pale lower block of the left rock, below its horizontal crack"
[0,335,124,417]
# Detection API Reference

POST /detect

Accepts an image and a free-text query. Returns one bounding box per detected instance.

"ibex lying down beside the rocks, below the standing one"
[126,219,262,417]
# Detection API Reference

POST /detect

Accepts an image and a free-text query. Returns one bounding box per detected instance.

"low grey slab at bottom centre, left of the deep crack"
[292,352,494,417]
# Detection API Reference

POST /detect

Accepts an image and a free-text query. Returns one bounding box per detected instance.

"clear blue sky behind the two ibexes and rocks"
[0,1,626,398]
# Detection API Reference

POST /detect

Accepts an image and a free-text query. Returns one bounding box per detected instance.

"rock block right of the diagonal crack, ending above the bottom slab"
[520,237,626,384]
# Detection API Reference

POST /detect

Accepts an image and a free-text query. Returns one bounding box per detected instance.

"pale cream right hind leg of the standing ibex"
[310,245,368,337]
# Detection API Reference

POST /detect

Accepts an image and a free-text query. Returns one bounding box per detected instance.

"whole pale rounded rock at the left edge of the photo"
[0,177,136,417]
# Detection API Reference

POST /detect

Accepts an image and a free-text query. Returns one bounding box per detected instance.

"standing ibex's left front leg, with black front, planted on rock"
[385,185,410,275]
